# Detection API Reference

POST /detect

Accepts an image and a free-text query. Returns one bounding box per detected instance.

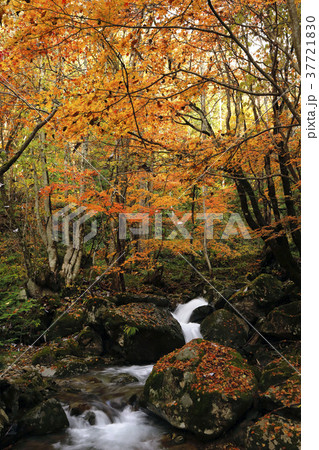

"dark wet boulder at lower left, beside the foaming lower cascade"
[18,398,69,435]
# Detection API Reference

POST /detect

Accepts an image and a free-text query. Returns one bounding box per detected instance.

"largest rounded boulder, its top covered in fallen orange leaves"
[144,339,257,439]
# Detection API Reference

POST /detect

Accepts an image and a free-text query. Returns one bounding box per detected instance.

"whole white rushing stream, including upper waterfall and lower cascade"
[12,298,207,450]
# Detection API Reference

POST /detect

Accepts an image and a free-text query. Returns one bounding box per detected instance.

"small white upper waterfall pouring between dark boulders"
[172,297,208,343]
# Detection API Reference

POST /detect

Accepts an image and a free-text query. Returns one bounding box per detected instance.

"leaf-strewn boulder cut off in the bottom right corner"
[246,414,301,450]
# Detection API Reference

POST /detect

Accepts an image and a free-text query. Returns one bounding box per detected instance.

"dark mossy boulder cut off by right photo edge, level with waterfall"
[260,301,301,339]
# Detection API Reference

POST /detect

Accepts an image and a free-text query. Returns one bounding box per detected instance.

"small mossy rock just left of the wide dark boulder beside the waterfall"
[47,311,85,341]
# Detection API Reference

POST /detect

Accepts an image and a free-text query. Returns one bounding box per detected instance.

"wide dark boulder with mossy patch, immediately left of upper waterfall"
[89,303,185,363]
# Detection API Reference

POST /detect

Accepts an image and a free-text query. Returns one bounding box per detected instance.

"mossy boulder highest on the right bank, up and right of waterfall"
[227,273,284,322]
